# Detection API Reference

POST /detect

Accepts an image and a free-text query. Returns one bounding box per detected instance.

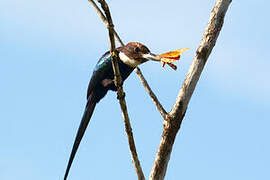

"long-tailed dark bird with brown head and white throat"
[64,42,161,180]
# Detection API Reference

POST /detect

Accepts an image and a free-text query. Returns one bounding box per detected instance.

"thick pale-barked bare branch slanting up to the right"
[150,0,232,180]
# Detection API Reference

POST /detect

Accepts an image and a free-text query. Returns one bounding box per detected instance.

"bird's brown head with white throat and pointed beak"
[118,42,160,67]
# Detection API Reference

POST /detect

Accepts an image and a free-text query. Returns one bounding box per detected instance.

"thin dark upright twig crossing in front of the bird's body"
[95,0,145,180]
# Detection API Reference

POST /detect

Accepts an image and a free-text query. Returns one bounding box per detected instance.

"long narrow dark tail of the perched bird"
[64,97,96,180]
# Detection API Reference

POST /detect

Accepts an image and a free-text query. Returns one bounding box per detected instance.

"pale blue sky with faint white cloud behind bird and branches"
[0,0,270,180]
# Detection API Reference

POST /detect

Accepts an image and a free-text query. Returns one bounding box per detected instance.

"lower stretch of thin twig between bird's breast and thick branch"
[135,68,167,119]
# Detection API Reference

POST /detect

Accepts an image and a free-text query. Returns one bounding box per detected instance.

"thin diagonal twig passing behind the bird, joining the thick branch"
[88,0,167,118]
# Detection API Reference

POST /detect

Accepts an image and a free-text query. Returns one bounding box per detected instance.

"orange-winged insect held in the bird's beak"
[159,48,189,70]
